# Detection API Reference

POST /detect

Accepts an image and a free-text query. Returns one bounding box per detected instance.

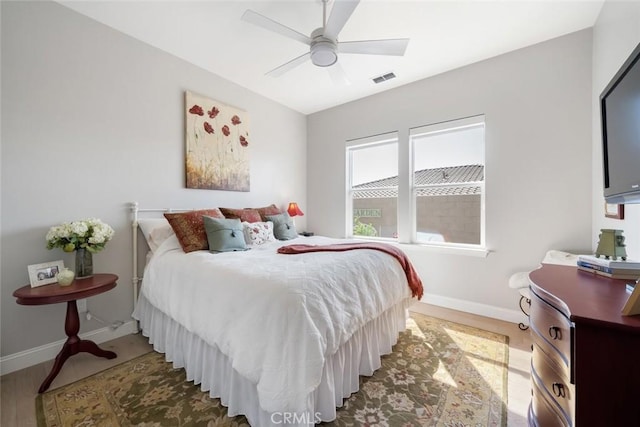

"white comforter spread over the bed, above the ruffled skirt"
[141,235,411,412]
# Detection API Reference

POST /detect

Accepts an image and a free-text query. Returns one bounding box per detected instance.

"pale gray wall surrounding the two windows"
[307,29,592,318]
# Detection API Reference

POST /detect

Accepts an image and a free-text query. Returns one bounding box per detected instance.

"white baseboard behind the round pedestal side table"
[0,320,137,375]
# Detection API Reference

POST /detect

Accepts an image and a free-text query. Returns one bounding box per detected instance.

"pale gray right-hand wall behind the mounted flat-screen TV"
[592,1,640,260]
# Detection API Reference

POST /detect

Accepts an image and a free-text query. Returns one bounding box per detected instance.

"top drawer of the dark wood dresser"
[530,292,572,368]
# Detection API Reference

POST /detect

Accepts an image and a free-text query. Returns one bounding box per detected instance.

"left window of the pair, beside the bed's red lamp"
[347,133,398,238]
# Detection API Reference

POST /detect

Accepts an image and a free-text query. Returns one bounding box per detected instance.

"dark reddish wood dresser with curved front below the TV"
[528,264,640,427]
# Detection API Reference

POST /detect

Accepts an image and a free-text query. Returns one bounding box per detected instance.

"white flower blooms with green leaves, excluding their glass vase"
[47,218,114,253]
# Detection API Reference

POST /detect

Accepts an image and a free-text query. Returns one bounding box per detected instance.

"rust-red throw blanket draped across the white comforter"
[278,242,423,299]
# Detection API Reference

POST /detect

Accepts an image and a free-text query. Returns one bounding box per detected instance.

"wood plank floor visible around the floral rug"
[0,306,531,427]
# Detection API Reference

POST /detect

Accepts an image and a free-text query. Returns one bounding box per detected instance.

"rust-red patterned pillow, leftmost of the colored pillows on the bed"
[164,208,224,252]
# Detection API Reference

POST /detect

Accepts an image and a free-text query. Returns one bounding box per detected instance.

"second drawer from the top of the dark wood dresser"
[531,344,575,424]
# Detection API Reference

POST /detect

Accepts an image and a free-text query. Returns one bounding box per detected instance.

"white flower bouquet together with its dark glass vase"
[46,218,114,279]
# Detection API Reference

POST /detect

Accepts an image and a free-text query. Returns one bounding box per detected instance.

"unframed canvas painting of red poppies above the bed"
[185,91,250,191]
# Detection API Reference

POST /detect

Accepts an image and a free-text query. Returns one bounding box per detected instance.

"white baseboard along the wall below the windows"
[409,294,526,323]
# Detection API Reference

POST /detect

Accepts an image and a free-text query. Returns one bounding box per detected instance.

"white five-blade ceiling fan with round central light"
[242,0,409,83]
